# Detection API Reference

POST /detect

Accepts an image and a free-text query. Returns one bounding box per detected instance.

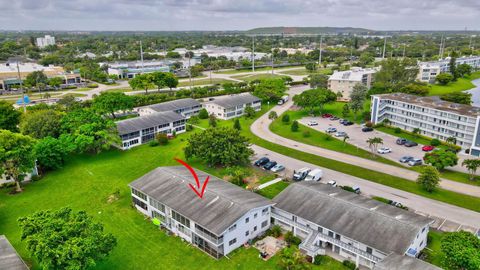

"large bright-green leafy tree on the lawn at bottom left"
[18,208,117,269]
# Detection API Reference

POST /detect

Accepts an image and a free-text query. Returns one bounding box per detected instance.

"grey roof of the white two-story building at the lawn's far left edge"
[116,112,185,135]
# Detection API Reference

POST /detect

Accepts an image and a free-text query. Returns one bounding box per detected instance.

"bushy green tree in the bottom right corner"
[441,231,480,270]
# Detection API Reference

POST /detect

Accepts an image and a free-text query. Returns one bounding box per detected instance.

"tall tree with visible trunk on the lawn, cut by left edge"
[0,130,35,192]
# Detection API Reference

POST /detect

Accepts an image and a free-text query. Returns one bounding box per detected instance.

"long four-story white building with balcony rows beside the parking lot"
[371,93,480,153]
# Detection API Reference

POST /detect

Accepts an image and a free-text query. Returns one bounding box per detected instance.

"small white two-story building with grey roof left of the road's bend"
[203,93,262,120]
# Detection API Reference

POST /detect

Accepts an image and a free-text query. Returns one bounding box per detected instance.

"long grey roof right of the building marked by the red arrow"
[273,182,433,254]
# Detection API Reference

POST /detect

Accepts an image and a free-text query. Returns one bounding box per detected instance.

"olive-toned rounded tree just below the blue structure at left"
[20,109,63,139]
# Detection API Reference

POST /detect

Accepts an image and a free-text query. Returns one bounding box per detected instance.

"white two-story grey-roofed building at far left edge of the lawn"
[116,112,186,150]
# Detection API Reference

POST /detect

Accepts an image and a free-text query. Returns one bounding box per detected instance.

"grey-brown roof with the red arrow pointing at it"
[129,166,273,236]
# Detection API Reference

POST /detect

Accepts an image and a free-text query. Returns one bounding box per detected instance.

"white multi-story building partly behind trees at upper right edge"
[417,56,480,83]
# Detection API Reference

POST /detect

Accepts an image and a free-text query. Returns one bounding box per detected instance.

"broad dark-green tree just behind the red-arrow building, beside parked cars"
[185,127,253,166]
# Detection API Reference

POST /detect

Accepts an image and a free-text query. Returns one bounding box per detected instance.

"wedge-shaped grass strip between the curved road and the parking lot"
[269,111,403,167]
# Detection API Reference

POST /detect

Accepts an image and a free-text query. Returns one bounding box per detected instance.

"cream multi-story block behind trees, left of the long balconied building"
[328,67,377,100]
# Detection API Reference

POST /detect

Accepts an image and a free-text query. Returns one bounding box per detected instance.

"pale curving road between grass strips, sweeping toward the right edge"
[250,86,480,197]
